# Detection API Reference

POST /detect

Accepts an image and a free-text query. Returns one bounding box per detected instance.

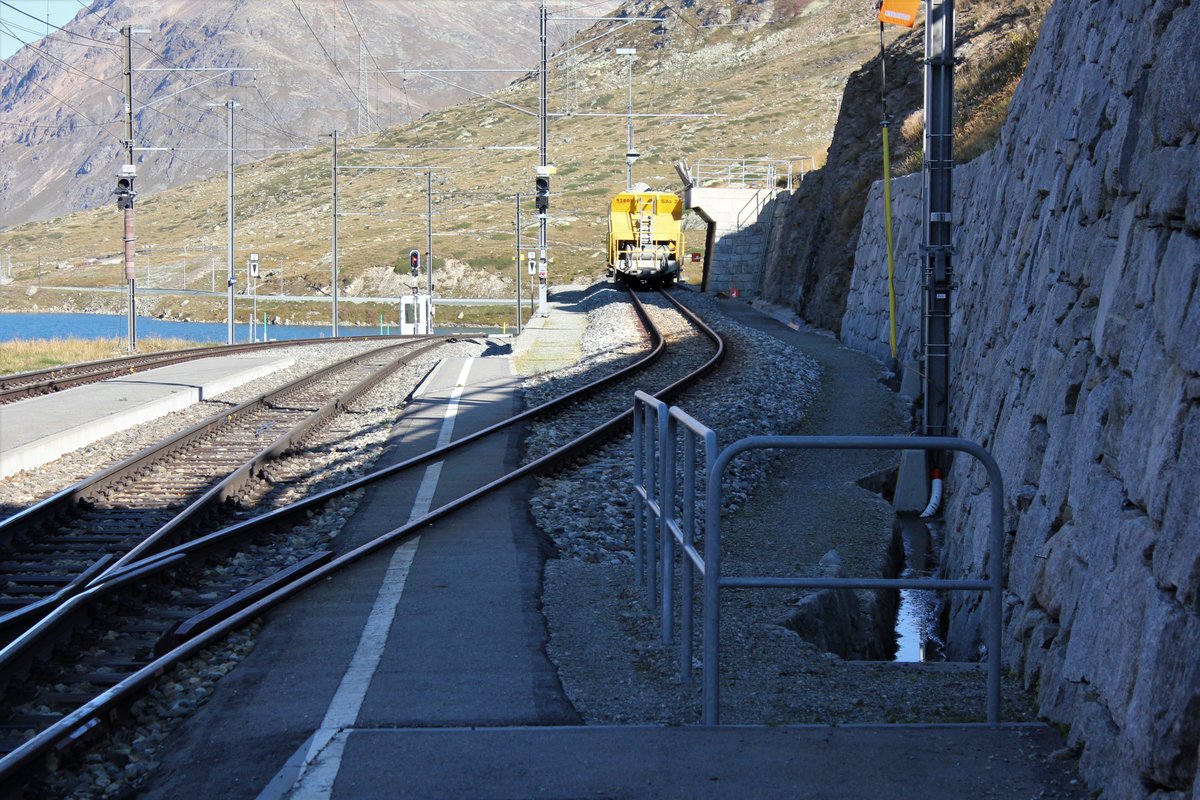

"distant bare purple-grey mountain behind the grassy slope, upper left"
[0,0,618,227]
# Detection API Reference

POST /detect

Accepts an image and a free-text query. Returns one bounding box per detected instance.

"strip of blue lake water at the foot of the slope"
[0,313,454,344]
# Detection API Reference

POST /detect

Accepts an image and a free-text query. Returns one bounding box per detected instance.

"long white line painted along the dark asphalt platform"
[259,359,475,800]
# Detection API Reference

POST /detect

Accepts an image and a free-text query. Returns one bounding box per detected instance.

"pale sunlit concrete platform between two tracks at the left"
[0,356,293,477]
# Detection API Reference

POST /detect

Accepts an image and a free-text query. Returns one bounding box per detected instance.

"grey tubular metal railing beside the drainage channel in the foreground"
[634,392,1004,724]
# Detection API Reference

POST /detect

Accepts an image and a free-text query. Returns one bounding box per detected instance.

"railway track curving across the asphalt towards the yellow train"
[0,286,724,784]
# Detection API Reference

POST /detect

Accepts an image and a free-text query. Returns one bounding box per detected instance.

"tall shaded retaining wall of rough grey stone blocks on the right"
[842,0,1200,800]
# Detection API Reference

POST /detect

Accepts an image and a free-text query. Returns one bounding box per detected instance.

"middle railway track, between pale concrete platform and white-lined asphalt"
[0,339,442,647]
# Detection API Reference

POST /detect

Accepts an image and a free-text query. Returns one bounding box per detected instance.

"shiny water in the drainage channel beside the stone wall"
[894,515,946,662]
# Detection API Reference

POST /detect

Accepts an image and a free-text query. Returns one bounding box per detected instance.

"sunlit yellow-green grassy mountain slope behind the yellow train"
[0,0,878,321]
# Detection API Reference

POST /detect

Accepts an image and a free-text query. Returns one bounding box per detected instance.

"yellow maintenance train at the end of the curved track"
[607,184,683,284]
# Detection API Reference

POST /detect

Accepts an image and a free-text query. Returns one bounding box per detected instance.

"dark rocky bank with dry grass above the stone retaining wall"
[761,0,1049,331]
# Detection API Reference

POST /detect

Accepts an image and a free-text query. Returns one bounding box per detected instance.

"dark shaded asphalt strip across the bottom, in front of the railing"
[297,726,1084,800]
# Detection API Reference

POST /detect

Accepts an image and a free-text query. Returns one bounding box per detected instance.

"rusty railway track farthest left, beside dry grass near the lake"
[0,336,415,405]
